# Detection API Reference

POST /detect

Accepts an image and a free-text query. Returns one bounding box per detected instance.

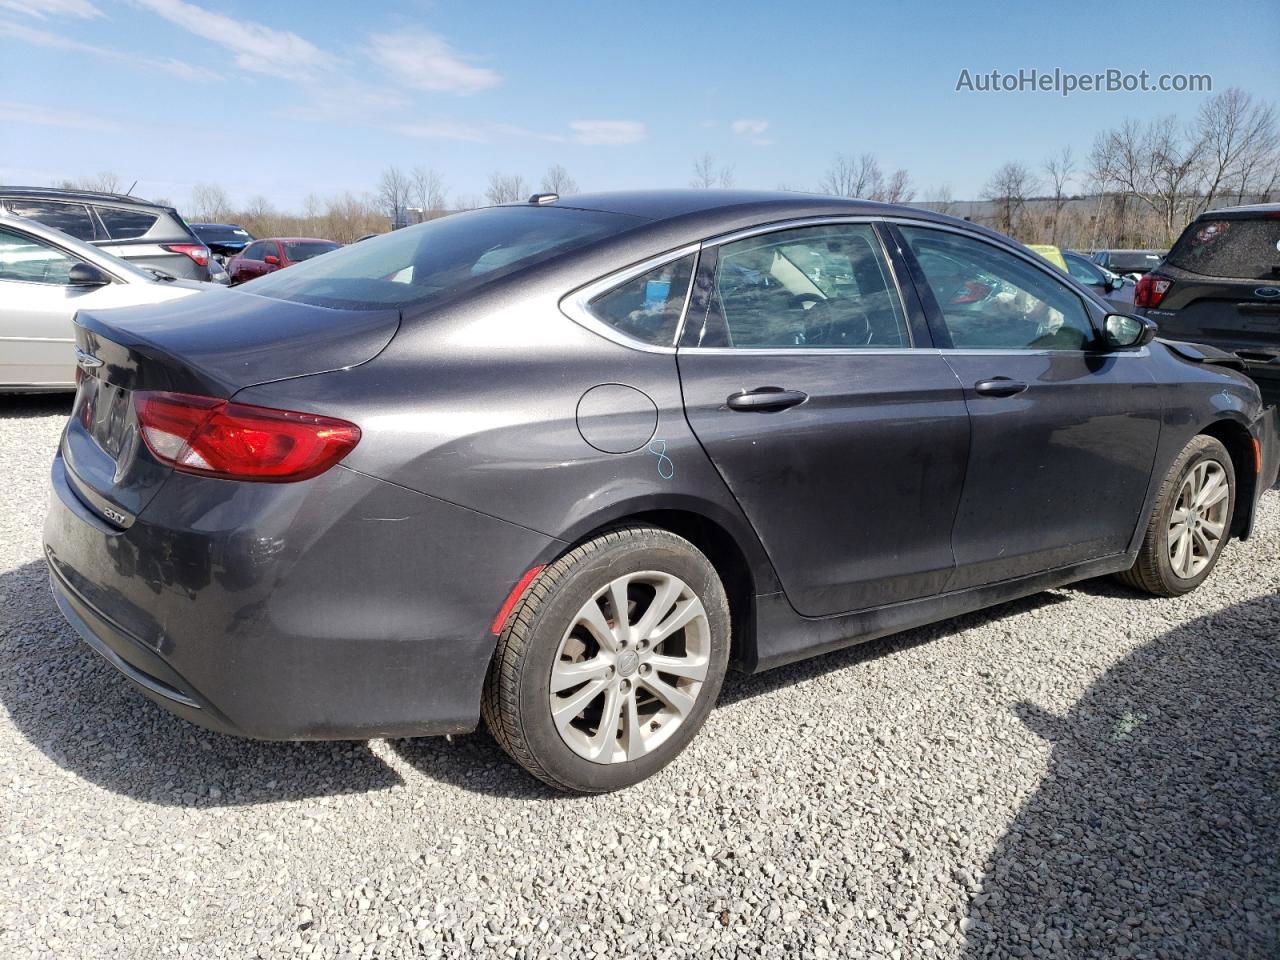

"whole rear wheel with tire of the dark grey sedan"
[481,526,730,794]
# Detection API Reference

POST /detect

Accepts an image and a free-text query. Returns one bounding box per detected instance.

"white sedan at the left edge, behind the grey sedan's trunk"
[0,215,209,393]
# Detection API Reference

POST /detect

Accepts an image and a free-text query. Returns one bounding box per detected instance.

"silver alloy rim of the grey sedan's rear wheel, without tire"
[550,571,712,763]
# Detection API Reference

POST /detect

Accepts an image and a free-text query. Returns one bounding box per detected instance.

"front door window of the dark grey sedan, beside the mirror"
[901,227,1093,349]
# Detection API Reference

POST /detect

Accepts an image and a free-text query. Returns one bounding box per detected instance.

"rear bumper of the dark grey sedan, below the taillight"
[45,457,557,740]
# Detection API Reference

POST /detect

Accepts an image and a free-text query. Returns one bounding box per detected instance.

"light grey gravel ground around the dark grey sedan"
[0,398,1280,960]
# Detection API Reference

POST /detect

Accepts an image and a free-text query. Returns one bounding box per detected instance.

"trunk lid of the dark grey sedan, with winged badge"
[60,288,399,527]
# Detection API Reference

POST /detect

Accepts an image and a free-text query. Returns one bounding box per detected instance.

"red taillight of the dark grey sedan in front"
[134,390,360,483]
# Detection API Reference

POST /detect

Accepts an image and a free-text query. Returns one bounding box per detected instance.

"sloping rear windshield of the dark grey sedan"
[243,206,644,310]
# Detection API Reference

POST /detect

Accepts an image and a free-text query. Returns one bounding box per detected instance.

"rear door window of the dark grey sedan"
[686,223,910,349]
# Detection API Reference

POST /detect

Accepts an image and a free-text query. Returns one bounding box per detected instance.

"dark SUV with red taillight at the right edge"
[1133,204,1280,403]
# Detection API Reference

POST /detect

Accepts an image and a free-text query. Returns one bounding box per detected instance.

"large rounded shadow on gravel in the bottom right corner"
[964,595,1280,959]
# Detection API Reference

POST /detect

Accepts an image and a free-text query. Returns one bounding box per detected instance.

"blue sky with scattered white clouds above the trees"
[0,0,1280,209]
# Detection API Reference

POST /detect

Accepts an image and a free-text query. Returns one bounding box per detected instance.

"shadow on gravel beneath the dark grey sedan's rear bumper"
[0,562,403,806]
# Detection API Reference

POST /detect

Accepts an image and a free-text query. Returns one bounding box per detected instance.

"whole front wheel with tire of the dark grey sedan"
[1116,435,1235,596]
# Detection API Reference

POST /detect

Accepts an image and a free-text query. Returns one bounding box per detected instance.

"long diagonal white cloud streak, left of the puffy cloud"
[133,0,338,79]
